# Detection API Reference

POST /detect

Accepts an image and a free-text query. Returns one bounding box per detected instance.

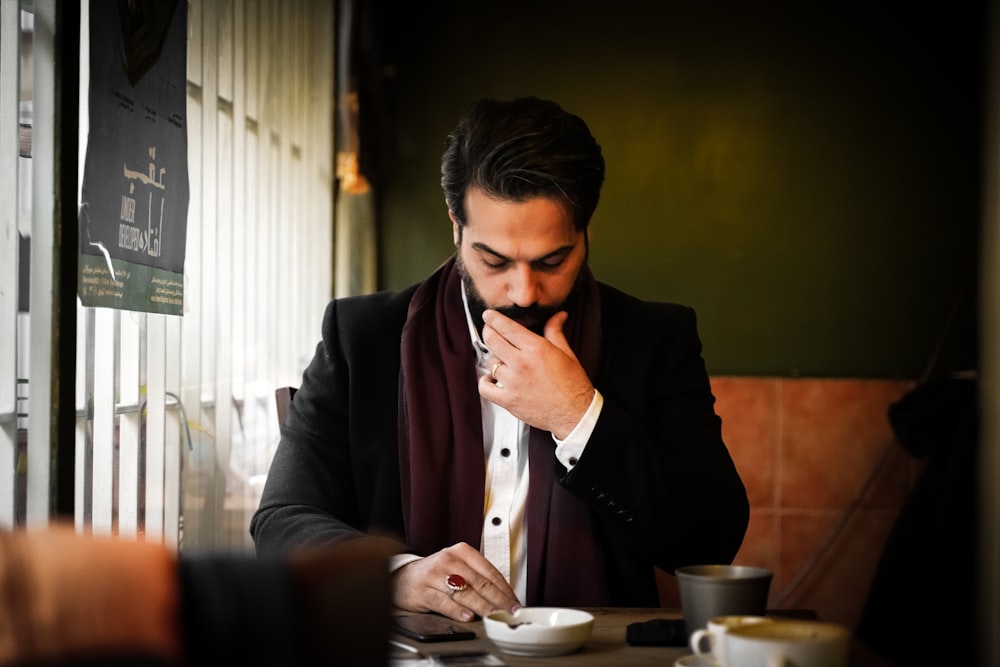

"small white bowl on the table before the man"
[483,607,594,656]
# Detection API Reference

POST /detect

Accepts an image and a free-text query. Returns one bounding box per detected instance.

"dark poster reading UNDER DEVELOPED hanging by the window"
[78,0,190,315]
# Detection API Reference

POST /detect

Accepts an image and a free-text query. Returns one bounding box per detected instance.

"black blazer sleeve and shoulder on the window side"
[250,293,409,555]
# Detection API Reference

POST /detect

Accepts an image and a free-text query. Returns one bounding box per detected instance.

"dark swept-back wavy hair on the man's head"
[441,97,604,231]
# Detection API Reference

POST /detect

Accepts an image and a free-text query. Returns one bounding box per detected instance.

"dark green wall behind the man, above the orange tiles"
[377,0,982,378]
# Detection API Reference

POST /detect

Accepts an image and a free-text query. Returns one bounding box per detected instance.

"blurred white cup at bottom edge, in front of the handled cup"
[723,619,851,667]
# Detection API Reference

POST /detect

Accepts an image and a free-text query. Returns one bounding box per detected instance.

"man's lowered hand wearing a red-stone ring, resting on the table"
[392,543,520,621]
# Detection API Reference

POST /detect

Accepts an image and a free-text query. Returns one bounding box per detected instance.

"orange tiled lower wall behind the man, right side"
[660,377,922,629]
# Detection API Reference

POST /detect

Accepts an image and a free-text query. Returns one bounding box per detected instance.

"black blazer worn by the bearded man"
[250,284,749,606]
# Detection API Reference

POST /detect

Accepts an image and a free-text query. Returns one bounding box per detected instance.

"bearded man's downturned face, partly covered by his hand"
[449,188,587,334]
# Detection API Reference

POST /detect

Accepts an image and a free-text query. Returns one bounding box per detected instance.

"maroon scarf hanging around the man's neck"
[399,258,609,606]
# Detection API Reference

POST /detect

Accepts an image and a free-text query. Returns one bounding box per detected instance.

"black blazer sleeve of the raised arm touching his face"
[562,296,749,572]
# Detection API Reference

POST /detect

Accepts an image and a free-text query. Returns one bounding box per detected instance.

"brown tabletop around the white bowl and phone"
[390,607,691,667]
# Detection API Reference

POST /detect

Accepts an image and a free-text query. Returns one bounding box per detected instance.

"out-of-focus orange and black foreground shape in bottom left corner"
[0,524,390,667]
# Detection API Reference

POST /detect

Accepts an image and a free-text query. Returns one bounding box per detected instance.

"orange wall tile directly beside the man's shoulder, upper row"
[712,377,780,508]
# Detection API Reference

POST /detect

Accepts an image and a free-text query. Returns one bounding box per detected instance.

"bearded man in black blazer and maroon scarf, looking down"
[250,98,749,620]
